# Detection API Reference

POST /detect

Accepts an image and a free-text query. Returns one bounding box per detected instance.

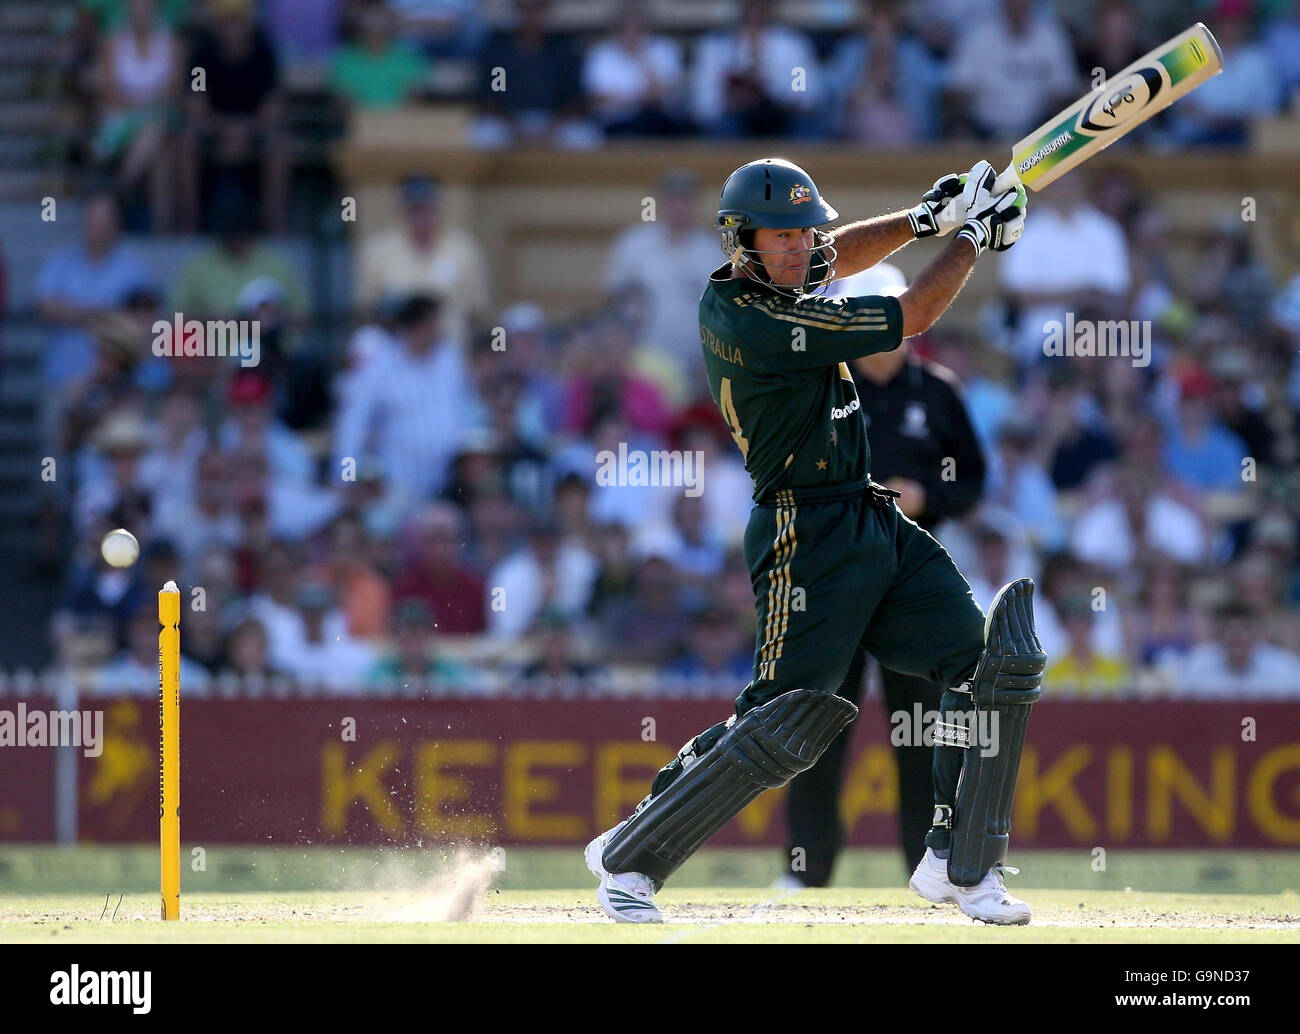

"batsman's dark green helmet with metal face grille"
[716,157,840,298]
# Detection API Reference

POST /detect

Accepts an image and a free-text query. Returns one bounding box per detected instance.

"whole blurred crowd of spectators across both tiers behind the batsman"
[30,0,1300,697]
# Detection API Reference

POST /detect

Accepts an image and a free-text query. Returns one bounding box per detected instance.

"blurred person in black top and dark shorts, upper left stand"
[179,0,290,233]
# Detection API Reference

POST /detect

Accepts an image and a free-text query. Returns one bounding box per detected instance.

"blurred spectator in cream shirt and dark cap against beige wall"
[356,176,489,345]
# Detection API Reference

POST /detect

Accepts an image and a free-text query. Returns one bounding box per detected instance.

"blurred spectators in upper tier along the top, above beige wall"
[61,0,1300,232]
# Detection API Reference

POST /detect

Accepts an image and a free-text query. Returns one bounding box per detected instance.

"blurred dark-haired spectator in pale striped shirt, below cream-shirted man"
[334,295,480,501]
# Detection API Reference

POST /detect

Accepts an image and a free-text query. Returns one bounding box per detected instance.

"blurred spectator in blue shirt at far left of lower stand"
[35,192,152,389]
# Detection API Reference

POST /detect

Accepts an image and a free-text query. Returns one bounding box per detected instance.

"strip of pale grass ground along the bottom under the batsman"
[0,845,1300,944]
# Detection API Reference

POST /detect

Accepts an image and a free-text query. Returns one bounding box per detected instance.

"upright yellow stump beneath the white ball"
[159,581,181,920]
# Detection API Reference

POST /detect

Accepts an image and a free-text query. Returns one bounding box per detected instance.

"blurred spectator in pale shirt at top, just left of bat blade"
[948,0,1079,140]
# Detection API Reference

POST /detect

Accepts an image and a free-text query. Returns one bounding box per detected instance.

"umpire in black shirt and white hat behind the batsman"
[785,263,984,887]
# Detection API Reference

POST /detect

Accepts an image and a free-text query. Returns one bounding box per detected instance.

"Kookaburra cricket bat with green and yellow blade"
[993,22,1223,194]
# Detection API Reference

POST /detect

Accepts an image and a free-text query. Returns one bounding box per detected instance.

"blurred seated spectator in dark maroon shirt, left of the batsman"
[393,502,488,636]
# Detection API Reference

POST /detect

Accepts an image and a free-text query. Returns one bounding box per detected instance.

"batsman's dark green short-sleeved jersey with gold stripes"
[699,265,902,502]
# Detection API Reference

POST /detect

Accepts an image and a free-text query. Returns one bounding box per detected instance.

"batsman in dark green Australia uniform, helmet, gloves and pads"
[586,159,1047,925]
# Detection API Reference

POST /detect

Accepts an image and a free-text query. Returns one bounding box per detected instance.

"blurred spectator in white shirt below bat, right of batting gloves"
[997,173,1131,364]
